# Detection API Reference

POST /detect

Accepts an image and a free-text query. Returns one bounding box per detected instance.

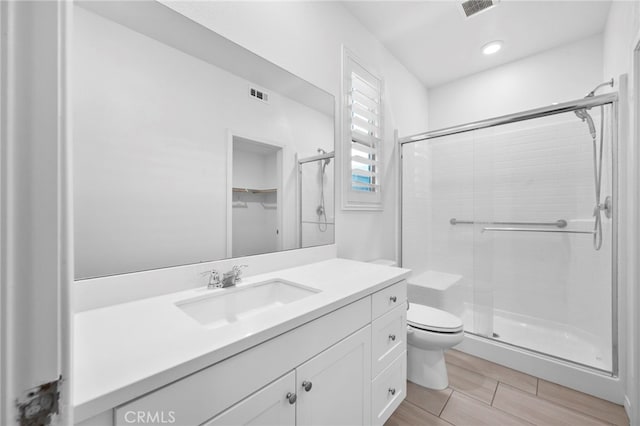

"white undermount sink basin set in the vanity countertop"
[176,279,320,328]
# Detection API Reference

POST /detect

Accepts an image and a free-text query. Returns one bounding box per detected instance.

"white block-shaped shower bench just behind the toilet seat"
[407,270,464,317]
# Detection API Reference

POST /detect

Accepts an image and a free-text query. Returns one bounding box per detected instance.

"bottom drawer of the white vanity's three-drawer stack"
[371,351,407,426]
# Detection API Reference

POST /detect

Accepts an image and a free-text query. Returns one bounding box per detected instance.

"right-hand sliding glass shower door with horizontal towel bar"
[471,108,613,371]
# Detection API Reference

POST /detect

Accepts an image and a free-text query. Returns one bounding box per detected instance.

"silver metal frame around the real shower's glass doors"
[397,92,619,377]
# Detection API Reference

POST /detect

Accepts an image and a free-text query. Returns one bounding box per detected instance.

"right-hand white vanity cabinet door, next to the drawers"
[296,325,371,426]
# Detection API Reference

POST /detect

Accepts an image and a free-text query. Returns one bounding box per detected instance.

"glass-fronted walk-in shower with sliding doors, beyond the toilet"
[399,94,618,376]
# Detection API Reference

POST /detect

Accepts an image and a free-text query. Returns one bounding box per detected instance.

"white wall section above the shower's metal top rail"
[429,35,603,130]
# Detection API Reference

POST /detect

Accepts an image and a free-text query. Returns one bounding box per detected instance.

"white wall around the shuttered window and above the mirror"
[164,1,427,260]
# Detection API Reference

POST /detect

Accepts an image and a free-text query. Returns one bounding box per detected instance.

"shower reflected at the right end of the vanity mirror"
[298,148,335,248]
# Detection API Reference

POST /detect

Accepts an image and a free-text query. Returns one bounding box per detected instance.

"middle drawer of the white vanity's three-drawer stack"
[371,304,407,377]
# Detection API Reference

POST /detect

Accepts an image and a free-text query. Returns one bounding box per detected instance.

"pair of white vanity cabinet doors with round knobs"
[205,326,371,426]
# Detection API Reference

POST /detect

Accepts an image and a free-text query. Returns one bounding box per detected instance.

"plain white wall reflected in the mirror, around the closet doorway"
[74,7,333,278]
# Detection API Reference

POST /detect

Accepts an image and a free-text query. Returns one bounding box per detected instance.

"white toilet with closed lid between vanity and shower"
[407,303,464,389]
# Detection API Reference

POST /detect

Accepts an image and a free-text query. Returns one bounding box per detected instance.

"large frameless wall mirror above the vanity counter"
[72,1,334,280]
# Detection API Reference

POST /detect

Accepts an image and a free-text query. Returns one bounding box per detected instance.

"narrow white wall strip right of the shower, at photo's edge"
[603,1,640,425]
